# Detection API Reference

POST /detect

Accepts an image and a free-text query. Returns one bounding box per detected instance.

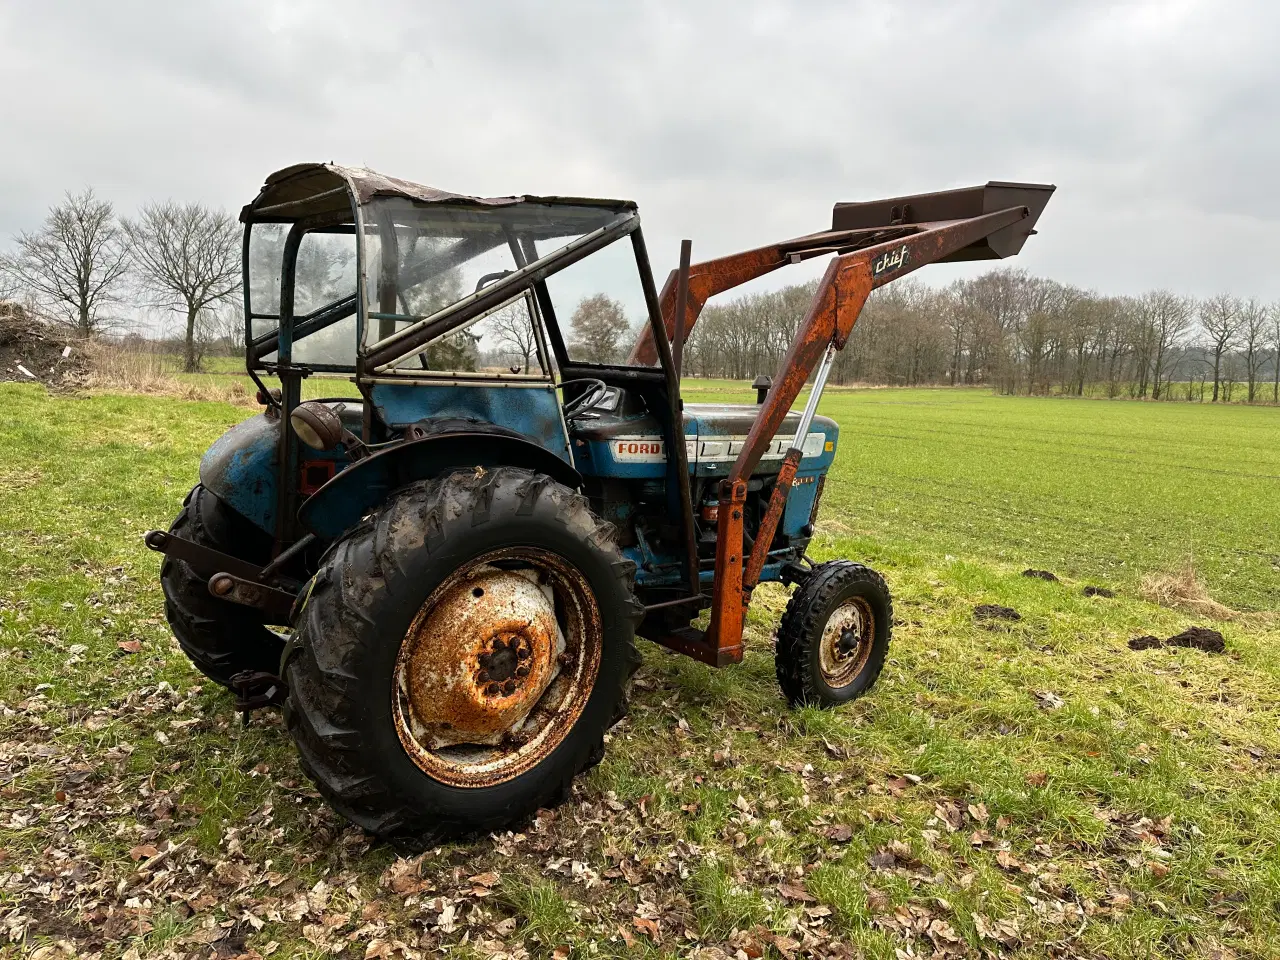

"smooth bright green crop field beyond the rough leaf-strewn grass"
[687,381,1280,609]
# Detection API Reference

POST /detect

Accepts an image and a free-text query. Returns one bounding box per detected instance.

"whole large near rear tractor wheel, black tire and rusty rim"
[282,467,643,836]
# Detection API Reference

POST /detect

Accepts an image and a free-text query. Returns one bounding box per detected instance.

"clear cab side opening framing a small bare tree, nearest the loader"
[539,237,649,364]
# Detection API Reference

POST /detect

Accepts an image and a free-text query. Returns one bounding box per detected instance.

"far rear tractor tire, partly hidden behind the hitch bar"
[160,484,284,689]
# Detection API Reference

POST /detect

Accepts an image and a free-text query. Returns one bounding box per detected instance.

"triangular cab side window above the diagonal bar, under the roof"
[364,198,618,353]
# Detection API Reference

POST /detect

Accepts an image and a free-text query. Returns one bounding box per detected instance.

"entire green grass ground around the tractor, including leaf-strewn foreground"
[0,383,1280,960]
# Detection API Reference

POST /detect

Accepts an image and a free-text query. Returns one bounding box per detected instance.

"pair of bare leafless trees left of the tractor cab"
[0,188,242,371]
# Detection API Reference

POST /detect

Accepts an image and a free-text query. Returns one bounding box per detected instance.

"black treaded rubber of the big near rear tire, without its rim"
[282,467,643,836]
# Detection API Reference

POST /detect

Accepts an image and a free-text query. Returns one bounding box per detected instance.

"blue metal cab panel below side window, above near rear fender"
[371,381,572,463]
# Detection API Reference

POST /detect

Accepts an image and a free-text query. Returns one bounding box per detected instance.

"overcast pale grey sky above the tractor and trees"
[0,0,1280,300]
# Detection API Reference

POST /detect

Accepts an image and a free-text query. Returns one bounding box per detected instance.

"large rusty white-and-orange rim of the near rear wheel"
[392,547,602,787]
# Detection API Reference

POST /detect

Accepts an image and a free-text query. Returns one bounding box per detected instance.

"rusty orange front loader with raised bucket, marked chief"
[631,182,1053,666]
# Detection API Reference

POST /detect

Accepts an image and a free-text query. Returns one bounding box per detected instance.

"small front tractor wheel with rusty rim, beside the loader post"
[774,561,893,707]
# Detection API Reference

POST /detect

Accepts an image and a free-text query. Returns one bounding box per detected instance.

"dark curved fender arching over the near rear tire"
[298,430,582,539]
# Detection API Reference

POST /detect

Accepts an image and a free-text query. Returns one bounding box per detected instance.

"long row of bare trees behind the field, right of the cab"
[685,268,1280,403]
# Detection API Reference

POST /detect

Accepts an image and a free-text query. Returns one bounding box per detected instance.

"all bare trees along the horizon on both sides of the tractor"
[0,189,1280,403]
